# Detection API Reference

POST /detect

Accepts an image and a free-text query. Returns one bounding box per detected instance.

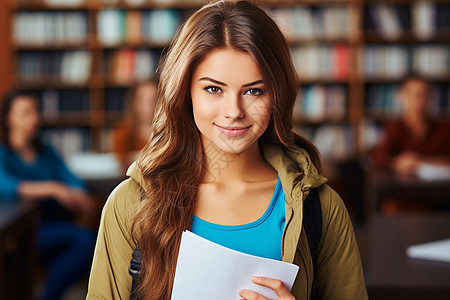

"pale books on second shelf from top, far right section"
[363,45,450,79]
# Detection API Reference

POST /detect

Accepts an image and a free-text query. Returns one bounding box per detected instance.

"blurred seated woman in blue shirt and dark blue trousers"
[0,91,95,300]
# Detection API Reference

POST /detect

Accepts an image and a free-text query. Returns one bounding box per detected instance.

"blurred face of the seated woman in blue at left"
[8,96,39,138]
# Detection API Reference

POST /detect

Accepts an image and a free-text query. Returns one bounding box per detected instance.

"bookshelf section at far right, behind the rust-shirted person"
[361,0,450,150]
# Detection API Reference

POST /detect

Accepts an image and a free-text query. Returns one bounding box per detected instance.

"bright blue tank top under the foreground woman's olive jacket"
[192,178,286,260]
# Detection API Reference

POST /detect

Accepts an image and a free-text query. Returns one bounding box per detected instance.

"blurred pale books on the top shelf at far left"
[12,11,88,47]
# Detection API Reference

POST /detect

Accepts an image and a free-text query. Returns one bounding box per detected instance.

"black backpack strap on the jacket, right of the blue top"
[303,189,322,300]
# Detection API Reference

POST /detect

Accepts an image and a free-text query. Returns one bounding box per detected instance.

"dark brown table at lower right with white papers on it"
[365,213,450,300]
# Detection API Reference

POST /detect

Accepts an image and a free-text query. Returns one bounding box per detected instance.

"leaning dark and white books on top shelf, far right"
[364,1,450,40]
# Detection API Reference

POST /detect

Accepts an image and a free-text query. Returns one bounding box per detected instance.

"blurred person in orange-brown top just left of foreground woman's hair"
[113,80,158,170]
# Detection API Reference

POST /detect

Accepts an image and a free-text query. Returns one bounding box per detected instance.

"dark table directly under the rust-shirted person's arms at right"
[365,169,450,220]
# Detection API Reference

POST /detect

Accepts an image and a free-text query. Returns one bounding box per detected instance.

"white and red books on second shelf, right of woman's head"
[292,44,350,80]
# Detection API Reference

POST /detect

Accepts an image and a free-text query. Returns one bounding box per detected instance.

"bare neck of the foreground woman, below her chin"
[203,142,277,186]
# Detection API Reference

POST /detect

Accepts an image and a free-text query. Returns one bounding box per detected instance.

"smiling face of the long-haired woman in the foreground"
[191,49,271,154]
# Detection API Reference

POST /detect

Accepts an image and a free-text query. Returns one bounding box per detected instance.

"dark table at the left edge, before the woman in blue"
[0,202,39,300]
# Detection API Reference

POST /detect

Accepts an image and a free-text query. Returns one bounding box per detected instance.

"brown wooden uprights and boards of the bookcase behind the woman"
[0,0,450,158]
